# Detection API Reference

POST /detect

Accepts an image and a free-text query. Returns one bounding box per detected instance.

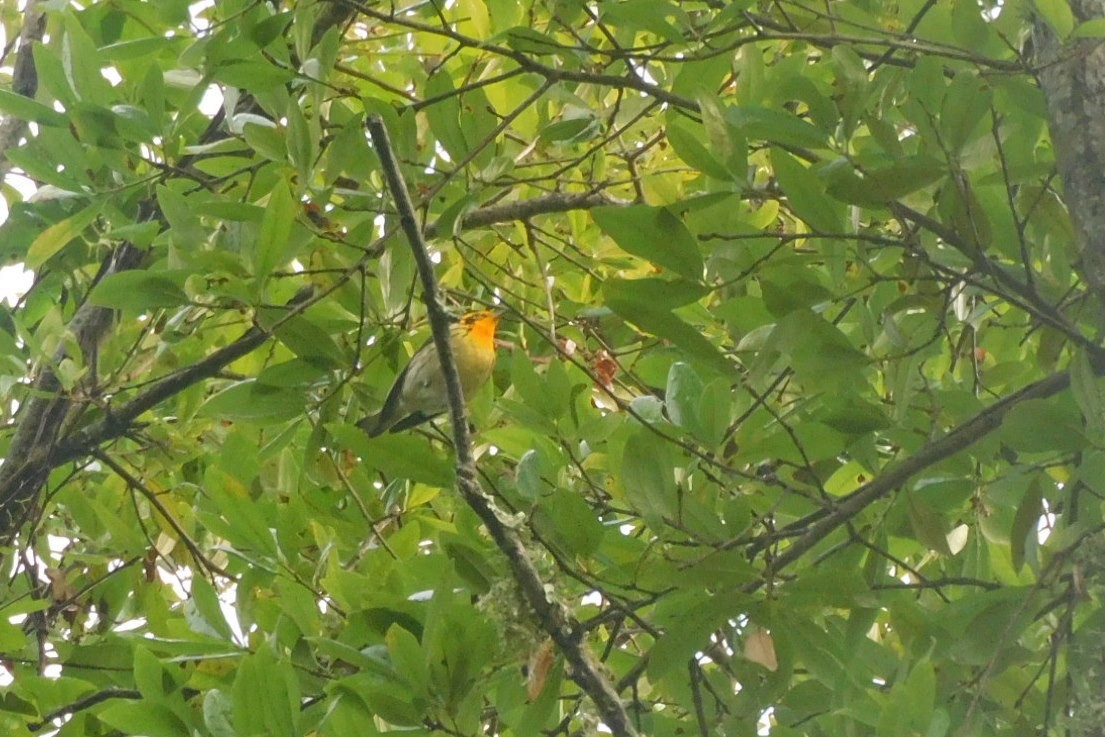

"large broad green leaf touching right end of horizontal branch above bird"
[591,204,703,281]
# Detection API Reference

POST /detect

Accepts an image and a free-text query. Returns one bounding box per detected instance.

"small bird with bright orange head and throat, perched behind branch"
[357,309,499,438]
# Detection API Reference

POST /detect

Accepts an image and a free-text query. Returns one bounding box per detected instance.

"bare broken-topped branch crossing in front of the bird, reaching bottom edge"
[367,116,638,737]
